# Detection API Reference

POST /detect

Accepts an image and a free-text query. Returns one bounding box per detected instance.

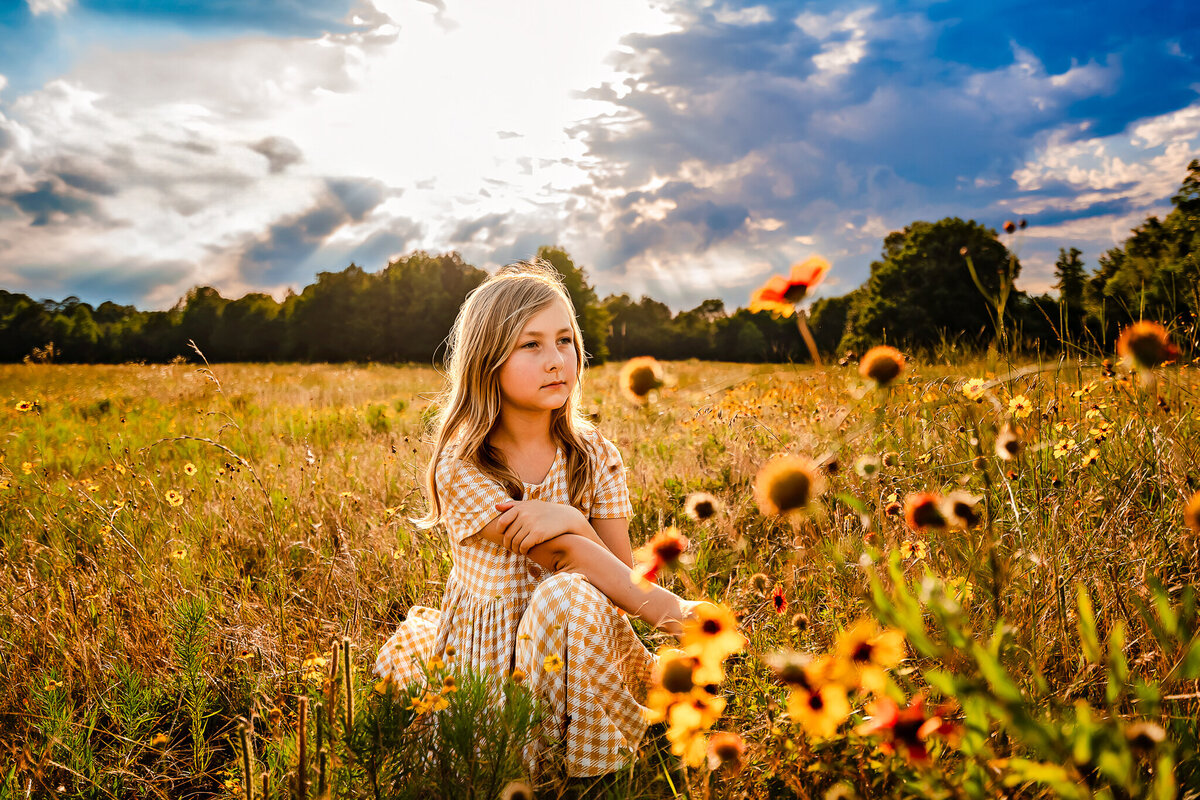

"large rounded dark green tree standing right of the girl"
[838,217,1020,350]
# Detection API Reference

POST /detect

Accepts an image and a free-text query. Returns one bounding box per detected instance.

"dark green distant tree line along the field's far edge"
[7,161,1200,363]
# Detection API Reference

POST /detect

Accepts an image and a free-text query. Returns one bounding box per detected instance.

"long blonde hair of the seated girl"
[415,258,595,528]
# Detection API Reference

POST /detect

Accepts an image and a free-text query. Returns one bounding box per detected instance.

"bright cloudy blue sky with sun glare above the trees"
[0,0,1200,311]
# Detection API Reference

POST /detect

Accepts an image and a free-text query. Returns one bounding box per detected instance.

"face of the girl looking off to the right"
[500,301,580,411]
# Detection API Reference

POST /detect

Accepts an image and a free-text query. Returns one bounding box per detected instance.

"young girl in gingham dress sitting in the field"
[374,261,696,777]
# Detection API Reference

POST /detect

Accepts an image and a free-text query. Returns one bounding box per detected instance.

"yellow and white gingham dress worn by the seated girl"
[374,433,654,776]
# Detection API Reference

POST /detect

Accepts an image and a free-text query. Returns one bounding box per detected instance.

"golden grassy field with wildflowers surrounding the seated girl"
[0,359,1200,798]
